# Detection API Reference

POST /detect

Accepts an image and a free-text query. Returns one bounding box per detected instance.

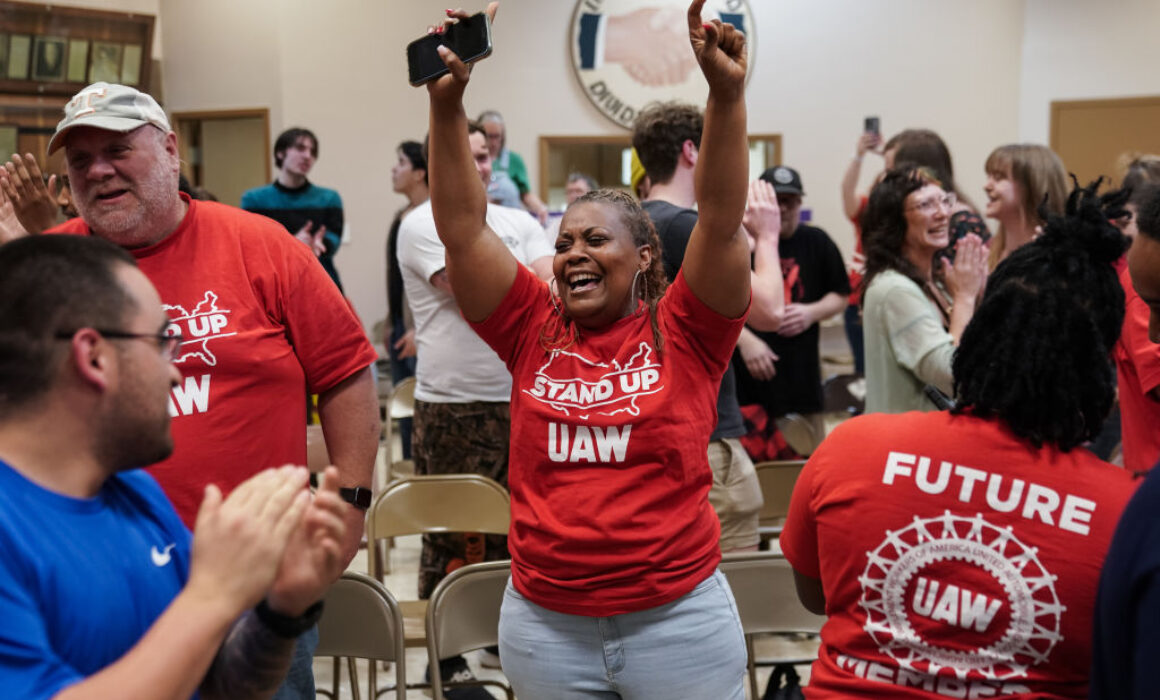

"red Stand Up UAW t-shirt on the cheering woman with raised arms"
[473,266,745,616]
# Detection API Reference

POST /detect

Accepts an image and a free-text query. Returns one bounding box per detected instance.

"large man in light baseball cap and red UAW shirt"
[49,82,379,700]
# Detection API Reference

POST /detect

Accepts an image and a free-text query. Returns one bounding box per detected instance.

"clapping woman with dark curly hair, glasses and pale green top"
[862,166,986,413]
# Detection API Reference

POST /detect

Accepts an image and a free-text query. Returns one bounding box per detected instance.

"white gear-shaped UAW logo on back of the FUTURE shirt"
[860,512,1065,680]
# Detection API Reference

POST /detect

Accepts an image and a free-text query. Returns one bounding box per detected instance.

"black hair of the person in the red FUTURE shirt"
[954,178,1129,452]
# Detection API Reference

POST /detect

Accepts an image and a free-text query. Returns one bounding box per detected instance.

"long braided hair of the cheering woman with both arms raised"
[539,188,668,354]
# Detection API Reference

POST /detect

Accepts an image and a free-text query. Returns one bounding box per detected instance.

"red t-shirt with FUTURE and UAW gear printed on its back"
[781,412,1133,699]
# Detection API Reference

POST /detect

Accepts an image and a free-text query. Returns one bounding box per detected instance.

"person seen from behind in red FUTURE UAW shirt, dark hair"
[781,186,1136,700]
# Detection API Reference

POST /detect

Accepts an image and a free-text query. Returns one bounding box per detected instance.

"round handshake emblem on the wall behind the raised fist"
[571,0,757,128]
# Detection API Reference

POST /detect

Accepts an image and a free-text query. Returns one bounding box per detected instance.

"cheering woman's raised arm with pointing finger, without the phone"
[682,0,749,318]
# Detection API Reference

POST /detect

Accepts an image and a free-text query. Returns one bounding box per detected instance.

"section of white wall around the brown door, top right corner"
[1018,0,1160,144]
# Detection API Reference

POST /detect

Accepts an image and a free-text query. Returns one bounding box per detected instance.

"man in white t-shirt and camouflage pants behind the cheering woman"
[398,123,553,698]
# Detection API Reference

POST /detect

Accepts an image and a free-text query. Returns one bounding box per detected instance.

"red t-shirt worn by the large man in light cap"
[53,195,377,527]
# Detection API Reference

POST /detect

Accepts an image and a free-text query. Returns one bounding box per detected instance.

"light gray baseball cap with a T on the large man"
[49,82,173,156]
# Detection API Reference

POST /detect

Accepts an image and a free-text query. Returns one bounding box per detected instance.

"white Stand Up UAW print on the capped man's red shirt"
[164,290,238,417]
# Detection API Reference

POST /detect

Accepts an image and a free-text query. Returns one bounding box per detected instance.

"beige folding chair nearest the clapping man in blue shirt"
[314,571,407,700]
